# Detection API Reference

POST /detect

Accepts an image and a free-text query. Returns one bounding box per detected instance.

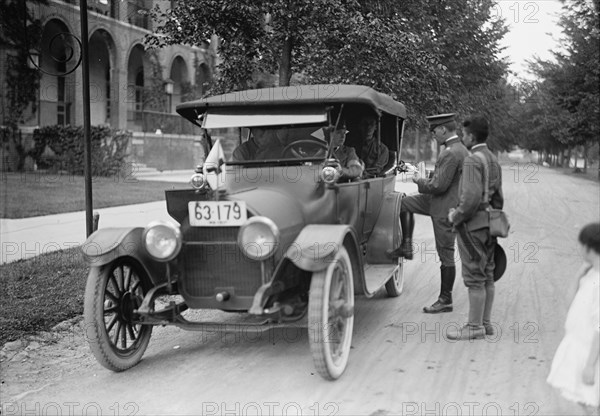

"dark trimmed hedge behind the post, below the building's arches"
[30,125,131,176]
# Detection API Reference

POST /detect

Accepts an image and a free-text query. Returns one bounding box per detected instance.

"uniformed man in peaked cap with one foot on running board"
[393,113,469,313]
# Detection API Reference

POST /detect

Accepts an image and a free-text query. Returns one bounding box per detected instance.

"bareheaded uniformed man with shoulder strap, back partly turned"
[447,116,504,340]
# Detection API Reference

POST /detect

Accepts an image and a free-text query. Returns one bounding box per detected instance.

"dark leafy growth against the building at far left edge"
[0,0,47,170]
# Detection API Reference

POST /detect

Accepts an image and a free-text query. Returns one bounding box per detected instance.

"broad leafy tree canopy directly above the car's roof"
[146,0,506,124]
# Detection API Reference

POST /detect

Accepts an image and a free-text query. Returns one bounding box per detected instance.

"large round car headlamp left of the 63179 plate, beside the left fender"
[142,221,182,261]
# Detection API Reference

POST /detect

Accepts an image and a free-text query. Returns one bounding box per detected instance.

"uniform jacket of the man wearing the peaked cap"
[416,137,469,218]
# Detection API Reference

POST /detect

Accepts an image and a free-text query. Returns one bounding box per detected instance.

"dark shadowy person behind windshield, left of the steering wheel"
[232,127,287,162]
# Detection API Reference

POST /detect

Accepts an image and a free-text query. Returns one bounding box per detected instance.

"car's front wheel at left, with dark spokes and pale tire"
[83,258,152,371]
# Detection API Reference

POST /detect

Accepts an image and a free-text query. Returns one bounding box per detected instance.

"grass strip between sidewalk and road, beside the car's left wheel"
[0,248,88,346]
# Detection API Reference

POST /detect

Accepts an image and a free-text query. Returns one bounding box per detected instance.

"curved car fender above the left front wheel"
[81,227,167,285]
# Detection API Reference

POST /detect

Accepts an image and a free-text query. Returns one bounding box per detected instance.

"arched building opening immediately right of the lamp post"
[89,29,118,126]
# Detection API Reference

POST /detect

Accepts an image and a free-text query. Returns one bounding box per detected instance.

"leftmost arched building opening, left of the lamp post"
[39,19,74,126]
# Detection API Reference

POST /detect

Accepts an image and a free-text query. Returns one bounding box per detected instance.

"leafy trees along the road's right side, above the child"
[505,0,600,177]
